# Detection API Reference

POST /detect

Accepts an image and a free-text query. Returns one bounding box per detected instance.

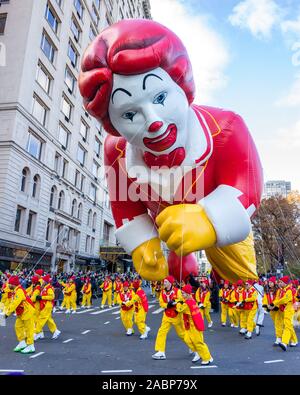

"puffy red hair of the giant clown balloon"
[79,19,195,136]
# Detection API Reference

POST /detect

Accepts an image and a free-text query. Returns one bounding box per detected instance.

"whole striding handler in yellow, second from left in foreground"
[34,275,61,340]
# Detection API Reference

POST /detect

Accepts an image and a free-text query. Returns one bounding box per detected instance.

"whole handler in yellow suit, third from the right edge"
[241,280,258,339]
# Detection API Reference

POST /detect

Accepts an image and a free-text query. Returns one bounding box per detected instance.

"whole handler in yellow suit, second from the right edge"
[262,276,283,346]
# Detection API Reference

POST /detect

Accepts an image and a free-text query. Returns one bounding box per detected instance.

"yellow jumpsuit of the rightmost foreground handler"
[273,285,298,345]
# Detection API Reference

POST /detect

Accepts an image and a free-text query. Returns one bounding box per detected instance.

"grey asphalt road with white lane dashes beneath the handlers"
[0,290,300,376]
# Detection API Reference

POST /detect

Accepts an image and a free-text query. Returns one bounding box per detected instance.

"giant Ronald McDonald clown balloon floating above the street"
[79,19,263,281]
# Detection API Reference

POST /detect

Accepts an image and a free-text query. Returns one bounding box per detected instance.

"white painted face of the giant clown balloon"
[109,68,189,155]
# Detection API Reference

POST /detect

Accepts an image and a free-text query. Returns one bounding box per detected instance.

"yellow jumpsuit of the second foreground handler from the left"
[35,284,57,333]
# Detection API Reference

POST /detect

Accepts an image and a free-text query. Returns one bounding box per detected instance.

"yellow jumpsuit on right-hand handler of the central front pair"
[177,303,211,361]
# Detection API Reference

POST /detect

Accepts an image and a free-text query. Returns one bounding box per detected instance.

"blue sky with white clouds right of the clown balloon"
[150,0,300,190]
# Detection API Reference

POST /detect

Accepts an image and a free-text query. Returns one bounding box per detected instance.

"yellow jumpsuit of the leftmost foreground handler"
[5,285,34,346]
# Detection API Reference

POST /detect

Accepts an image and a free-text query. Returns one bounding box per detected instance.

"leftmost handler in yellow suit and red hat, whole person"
[5,276,35,354]
